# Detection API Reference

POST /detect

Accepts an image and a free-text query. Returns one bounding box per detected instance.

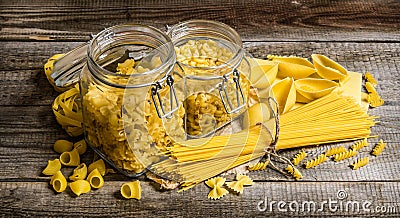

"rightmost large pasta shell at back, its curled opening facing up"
[311,54,347,82]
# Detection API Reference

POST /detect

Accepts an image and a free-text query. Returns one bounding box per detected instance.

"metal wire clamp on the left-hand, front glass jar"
[151,75,179,118]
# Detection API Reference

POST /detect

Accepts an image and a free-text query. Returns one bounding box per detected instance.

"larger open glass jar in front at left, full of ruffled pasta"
[80,24,178,175]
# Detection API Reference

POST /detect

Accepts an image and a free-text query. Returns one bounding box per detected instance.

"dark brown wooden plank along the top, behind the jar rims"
[0,0,400,41]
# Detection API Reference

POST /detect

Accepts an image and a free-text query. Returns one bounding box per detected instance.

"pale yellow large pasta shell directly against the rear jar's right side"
[250,58,278,89]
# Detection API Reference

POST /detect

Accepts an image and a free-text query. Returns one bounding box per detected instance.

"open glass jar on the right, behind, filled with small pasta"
[167,20,251,138]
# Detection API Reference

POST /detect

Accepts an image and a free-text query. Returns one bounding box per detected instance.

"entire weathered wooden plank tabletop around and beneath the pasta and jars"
[0,0,400,217]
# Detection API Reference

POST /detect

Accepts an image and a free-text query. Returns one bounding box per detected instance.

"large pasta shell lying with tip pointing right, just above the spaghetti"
[294,78,339,103]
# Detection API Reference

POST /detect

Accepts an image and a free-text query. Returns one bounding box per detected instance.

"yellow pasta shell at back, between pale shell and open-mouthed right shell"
[272,57,316,79]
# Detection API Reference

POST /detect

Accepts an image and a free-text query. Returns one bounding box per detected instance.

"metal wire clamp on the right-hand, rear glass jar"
[218,69,246,114]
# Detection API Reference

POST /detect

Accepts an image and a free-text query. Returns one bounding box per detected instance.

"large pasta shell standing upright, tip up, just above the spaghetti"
[270,77,296,114]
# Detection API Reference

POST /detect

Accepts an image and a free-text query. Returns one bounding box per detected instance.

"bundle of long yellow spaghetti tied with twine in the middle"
[151,93,375,189]
